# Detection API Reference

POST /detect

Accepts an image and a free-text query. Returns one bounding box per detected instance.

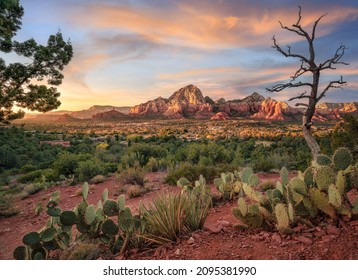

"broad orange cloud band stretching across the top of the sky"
[67,3,358,48]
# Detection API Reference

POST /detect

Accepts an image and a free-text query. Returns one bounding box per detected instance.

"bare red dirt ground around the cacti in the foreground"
[0,173,358,260]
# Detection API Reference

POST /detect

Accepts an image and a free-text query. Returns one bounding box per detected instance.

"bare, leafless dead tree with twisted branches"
[266,6,348,159]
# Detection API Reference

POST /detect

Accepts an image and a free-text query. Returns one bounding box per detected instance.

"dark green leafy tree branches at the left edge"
[0,0,73,123]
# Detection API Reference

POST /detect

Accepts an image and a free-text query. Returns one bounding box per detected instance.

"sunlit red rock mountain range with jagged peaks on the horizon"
[130,85,358,121]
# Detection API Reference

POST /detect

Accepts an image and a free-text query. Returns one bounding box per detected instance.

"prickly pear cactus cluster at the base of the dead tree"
[233,148,358,234]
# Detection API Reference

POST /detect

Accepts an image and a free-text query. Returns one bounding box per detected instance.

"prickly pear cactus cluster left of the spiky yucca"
[13,183,144,260]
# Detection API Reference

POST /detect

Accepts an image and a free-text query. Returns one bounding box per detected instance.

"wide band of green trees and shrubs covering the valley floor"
[0,117,358,185]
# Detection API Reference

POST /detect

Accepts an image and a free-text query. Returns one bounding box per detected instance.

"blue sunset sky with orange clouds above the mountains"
[7,0,358,110]
